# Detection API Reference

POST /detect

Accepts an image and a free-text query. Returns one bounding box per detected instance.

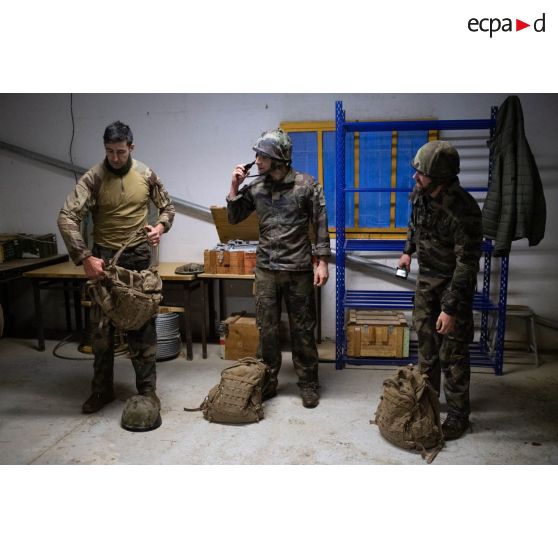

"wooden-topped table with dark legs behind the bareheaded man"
[24,262,203,360]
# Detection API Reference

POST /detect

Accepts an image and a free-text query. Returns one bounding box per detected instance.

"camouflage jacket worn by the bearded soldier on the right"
[403,180,482,315]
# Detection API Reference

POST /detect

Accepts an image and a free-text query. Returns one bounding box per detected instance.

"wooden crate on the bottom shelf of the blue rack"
[346,309,409,358]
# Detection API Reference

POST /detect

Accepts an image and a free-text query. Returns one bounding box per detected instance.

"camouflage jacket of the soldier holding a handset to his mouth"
[227,169,331,271]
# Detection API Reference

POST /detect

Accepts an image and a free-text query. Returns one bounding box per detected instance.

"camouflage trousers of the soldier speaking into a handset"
[255,268,319,387]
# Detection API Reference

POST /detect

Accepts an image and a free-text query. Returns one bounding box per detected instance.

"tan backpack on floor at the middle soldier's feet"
[184,357,269,424]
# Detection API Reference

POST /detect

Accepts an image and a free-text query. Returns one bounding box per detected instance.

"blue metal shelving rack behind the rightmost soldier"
[335,101,509,375]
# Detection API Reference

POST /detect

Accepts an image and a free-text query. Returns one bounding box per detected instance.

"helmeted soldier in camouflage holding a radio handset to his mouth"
[227,129,331,408]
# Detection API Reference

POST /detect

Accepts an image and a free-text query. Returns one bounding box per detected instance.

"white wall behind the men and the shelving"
[0,93,558,346]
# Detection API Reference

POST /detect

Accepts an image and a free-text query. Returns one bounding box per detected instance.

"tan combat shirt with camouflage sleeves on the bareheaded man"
[58,159,175,265]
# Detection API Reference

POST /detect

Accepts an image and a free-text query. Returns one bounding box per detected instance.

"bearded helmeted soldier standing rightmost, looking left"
[399,141,482,440]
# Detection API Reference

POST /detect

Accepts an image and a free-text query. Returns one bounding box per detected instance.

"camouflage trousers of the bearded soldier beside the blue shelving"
[413,278,474,417]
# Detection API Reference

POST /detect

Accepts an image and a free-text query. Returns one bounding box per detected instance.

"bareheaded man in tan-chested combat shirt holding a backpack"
[58,121,175,413]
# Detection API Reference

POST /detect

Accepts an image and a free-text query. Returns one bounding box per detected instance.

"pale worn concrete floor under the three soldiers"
[0,339,558,465]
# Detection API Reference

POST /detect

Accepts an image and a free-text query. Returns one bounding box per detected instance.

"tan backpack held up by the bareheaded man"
[87,228,163,331]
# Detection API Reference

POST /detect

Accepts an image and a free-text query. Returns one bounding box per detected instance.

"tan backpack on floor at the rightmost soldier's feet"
[373,365,444,463]
